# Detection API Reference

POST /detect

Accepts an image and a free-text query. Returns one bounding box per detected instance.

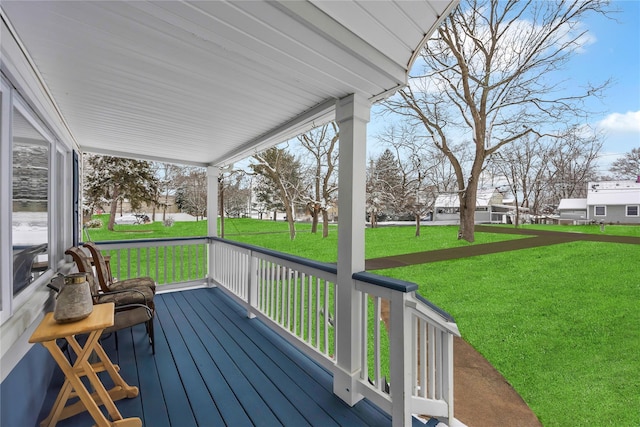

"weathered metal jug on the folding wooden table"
[53,273,93,323]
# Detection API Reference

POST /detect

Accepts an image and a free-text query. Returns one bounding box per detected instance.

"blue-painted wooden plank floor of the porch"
[39,289,396,427]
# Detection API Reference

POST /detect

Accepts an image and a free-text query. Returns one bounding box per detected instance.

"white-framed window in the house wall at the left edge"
[0,74,72,324]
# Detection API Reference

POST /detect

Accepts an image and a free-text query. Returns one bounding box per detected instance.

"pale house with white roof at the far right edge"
[558,179,640,224]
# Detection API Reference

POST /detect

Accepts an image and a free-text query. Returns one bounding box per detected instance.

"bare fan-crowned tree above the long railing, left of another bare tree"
[250,147,304,240]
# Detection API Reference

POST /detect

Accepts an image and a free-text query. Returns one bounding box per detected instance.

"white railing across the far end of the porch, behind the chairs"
[95,237,209,292]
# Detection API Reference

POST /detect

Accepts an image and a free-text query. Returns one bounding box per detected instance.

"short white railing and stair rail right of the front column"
[354,272,461,425]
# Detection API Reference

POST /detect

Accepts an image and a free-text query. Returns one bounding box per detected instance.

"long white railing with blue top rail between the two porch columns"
[211,238,336,370]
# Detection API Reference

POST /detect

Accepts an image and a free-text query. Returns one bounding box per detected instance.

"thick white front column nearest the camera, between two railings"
[333,94,371,405]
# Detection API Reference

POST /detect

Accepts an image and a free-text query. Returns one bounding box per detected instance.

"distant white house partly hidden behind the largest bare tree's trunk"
[433,188,523,223]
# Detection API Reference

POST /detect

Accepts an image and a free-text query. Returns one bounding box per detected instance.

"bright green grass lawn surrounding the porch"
[90,219,640,426]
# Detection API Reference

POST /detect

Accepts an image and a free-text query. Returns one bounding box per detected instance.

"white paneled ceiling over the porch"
[1,0,457,165]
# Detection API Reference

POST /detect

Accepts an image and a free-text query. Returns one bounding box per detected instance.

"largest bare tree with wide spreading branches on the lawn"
[384,0,608,242]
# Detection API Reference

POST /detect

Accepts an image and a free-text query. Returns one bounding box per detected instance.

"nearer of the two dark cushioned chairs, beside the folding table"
[65,246,156,354]
